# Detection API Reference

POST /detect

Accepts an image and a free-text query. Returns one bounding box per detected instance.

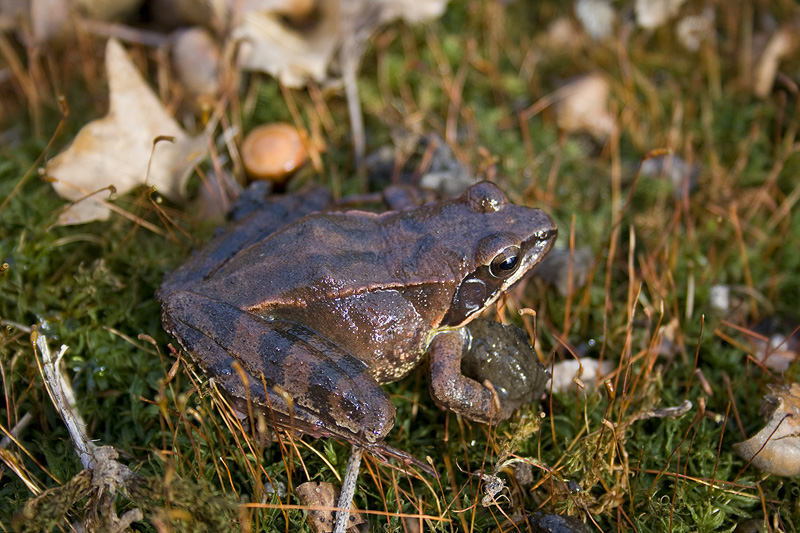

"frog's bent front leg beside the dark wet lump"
[428,328,517,424]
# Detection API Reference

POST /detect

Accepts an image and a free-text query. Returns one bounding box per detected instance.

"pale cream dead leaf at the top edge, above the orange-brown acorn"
[232,0,447,87]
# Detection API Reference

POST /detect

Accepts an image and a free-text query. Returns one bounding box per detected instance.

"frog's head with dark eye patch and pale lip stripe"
[441,182,558,327]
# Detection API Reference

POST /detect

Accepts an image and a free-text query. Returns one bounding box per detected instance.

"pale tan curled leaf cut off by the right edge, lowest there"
[733,383,800,476]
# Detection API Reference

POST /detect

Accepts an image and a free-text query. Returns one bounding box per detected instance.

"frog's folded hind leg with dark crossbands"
[163,290,395,447]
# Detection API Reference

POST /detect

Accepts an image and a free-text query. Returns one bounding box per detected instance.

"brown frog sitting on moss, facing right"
[157,181,558,470]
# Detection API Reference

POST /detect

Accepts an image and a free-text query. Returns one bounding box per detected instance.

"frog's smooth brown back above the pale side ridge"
[198,211,450,314]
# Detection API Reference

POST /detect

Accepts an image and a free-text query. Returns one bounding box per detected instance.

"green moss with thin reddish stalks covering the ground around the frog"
[0,1,800,531]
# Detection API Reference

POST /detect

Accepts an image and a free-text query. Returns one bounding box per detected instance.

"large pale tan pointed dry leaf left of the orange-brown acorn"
[47,39,208,225]
